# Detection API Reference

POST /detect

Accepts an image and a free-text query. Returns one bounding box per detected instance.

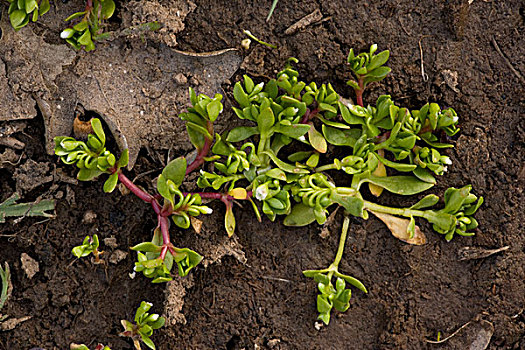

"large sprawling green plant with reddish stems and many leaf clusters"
[55,45,483,324]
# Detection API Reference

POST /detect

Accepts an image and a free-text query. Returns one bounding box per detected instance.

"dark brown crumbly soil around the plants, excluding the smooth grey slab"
[0,0,525,350]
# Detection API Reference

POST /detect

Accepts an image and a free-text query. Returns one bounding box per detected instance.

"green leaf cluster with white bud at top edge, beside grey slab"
[60,0,115,51]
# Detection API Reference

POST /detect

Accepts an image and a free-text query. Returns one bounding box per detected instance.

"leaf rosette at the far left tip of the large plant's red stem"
[54,118,129,193]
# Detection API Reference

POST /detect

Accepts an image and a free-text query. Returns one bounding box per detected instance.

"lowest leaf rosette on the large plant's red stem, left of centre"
[131,229,202,283]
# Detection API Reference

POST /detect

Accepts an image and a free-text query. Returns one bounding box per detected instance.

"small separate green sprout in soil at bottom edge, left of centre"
[120,301,166,350]
